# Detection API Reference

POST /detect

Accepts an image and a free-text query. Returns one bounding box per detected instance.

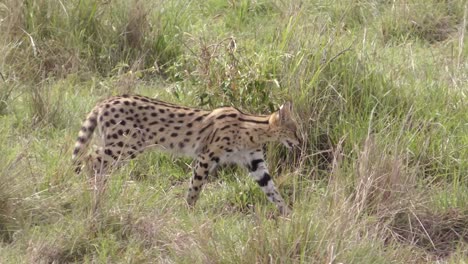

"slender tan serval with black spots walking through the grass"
[73,95,299,214]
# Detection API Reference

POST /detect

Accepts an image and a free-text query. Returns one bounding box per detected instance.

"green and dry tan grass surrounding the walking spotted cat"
[0,0,468,263]
